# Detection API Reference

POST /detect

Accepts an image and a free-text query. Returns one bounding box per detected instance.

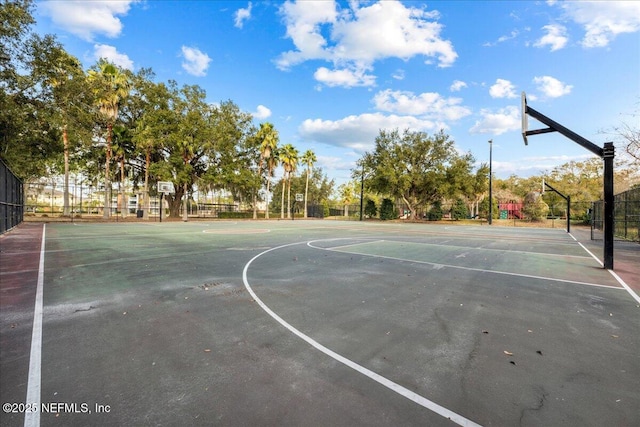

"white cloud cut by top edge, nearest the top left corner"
[38,0,135,41]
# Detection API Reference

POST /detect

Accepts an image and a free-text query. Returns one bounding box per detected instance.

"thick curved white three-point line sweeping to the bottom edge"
[242,239,479,426]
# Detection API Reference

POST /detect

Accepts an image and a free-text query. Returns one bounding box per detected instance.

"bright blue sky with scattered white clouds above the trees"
[35,0,640,184]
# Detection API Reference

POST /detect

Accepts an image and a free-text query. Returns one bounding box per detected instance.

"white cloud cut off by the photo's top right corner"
[554,1,640,48]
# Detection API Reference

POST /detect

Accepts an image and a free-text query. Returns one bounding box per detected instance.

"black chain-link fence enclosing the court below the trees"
[18,173,640,242]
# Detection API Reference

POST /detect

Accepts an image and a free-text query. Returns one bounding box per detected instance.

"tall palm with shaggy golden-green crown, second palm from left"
[88,59,130,218]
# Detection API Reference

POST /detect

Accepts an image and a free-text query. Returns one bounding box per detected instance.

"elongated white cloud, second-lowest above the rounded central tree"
[373,89,471,121]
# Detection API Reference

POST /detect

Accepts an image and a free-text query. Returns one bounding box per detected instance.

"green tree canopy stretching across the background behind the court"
[0,0,640,219]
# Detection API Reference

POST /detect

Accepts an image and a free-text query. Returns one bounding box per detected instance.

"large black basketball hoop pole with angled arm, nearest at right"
[522,92,615,270]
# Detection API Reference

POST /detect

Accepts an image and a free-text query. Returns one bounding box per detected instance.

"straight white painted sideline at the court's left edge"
[24,224,47,427]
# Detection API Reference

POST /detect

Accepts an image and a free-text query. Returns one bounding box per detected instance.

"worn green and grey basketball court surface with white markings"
[0,221,640,426]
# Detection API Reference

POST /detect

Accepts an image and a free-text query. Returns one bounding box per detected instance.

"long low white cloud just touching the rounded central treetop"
[298,113,439,152]
